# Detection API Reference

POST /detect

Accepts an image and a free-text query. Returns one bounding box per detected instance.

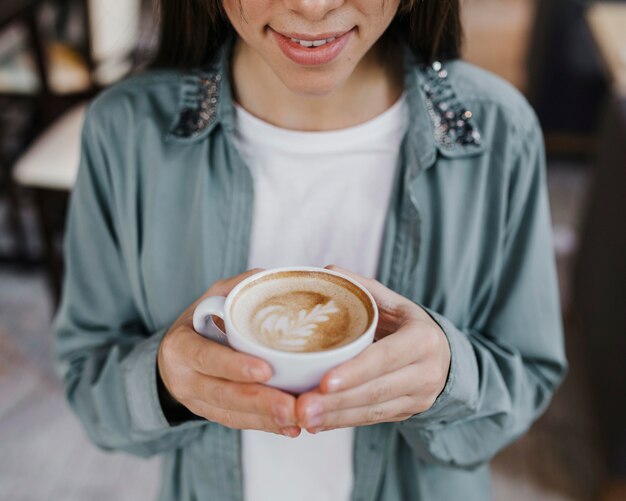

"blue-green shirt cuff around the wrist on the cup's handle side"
[123,329,204,432]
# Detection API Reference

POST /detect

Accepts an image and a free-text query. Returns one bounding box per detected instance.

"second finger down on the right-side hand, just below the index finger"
[296,365,421,428]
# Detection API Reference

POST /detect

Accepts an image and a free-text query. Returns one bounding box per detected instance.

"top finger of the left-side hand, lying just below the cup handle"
[171,328,272,382]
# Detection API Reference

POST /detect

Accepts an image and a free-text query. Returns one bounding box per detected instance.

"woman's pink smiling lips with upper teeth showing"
[269,28,354,66]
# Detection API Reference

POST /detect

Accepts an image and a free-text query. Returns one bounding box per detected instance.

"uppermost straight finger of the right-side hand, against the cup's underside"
[320,321,438,393]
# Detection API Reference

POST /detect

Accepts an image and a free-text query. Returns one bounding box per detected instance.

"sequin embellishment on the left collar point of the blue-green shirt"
[172,73,222,138]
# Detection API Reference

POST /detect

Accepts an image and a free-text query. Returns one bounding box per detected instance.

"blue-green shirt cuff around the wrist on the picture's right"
[405,306,479,427]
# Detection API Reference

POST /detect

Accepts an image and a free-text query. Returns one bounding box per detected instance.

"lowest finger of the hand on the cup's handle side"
[188,400,301,438]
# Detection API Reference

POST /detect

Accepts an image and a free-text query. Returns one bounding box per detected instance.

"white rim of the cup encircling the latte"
[224,266,378,360]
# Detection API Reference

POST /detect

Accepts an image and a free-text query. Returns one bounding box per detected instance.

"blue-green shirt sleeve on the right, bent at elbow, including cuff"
[398,118,567,468]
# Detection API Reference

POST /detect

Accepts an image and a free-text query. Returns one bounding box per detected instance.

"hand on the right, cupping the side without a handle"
[296,266,450,433]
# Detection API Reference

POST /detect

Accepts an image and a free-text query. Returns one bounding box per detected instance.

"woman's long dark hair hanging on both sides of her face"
[153,0,462,68]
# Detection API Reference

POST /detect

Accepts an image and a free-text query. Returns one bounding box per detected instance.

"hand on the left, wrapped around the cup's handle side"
[157,269,300,437]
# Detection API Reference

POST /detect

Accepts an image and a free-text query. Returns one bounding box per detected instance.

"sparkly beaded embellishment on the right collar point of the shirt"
[421,61,481,150]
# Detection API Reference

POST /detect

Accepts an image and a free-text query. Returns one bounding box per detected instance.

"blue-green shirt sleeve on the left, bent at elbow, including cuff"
[54,105,207,456]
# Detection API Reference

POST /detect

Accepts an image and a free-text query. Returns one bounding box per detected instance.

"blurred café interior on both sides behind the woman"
[0,0,626,501]
